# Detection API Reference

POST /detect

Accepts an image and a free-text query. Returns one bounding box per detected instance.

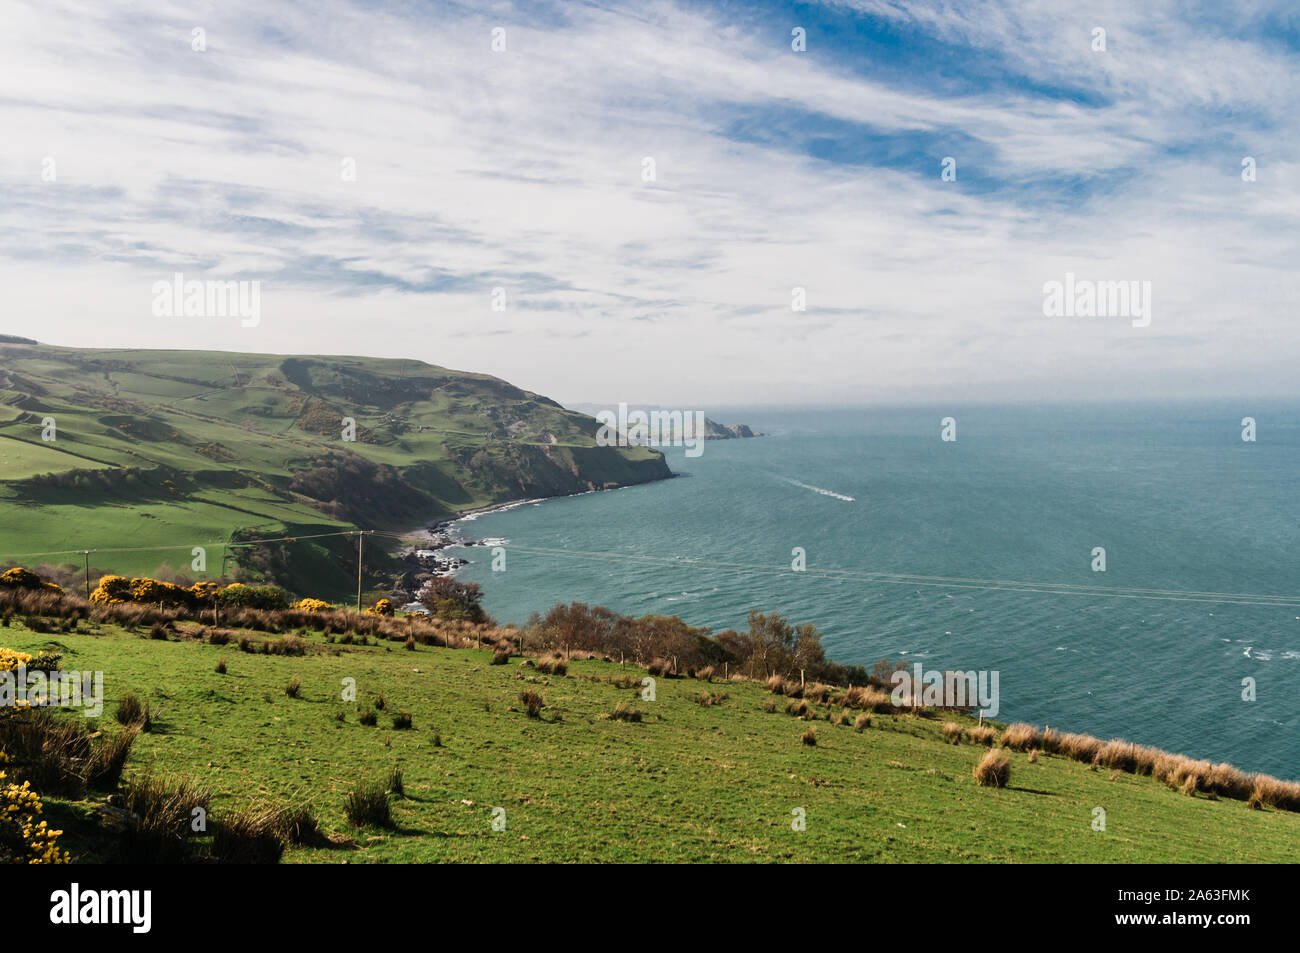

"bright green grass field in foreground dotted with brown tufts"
[0,619,1300,863]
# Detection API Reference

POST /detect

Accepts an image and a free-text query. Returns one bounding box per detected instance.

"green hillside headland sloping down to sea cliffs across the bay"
[0,342,670,595]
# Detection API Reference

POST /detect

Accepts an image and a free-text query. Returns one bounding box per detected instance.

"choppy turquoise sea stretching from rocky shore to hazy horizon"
[458,400,1300,779]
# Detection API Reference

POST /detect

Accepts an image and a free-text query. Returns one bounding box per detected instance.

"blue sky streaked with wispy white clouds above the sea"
[0,0,1300,410]
